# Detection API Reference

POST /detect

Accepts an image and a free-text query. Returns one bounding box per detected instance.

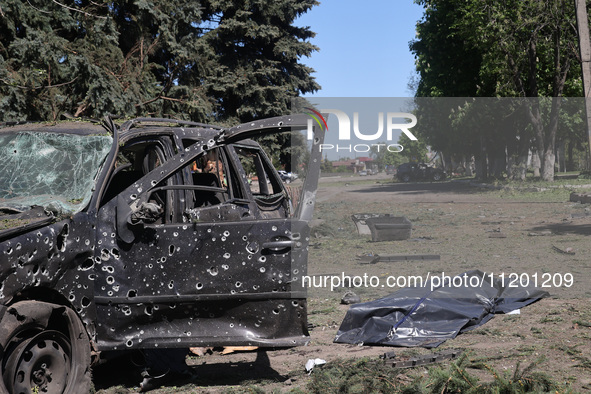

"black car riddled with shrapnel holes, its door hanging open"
[0,115,323,393]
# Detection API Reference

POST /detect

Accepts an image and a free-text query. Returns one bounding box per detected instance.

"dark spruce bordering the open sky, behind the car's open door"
[198,0,319,122]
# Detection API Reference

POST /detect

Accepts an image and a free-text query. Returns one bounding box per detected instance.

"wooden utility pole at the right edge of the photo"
[575,0,591,170]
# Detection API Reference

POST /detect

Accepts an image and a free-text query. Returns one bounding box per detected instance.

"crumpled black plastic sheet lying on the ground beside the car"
[334,270,549,348]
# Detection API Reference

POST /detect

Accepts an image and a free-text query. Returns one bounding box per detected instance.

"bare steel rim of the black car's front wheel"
[5,331,71,394]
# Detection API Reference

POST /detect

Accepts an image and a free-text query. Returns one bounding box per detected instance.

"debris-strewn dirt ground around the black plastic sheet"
[95,174,591,394]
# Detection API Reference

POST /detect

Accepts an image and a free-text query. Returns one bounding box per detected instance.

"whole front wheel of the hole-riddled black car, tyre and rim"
[0,301,92,394]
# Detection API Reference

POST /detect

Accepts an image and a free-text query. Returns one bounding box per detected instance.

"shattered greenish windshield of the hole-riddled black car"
[0,131,113,214]
